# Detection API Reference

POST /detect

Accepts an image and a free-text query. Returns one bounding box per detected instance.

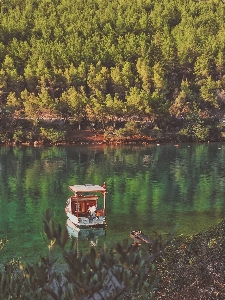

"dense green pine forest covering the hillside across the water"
[0,0,225,141]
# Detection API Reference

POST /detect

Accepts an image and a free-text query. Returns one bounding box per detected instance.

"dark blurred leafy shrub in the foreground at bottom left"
[0,209,173,300]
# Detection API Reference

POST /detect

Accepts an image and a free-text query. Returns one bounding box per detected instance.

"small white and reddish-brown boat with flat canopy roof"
[65,182,106,231]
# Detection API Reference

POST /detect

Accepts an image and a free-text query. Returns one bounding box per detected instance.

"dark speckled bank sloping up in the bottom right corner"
[155,220,225,300]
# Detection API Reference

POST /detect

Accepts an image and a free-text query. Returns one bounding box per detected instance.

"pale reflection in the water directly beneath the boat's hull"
[66,219,106,246]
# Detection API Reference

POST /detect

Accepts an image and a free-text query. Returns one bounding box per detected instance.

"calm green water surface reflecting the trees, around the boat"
[0,143,225,262]
